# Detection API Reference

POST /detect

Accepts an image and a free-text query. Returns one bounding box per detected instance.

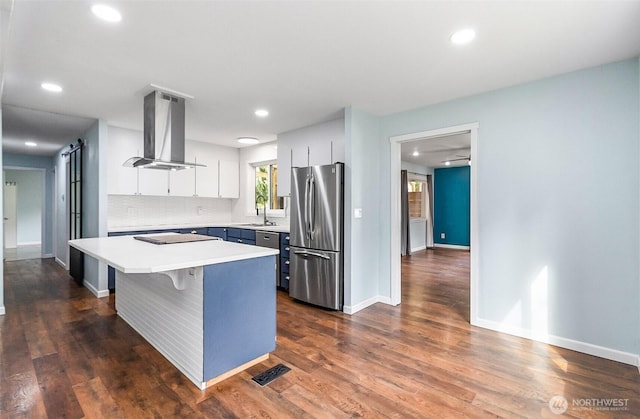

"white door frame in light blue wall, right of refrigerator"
[389,122,480,325]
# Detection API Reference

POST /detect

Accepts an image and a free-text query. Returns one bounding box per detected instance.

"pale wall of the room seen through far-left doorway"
[4,169,44,246]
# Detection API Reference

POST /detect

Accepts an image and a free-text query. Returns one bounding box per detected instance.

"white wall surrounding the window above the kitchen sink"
[232,141,289,225]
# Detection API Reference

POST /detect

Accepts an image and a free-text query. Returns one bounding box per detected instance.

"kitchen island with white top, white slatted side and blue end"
[69,236,278,389]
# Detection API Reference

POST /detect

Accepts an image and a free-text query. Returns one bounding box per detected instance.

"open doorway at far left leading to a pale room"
[3,167,45,261]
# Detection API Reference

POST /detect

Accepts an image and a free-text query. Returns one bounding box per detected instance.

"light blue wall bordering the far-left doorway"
[2,153,54,257]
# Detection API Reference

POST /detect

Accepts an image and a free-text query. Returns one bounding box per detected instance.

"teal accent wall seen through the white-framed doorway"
[433,166,471,246]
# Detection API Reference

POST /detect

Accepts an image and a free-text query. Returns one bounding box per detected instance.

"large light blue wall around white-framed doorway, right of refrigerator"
[347,58,640,354]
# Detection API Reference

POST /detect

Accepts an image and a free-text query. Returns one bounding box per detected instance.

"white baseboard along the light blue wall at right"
[474,319,640,372]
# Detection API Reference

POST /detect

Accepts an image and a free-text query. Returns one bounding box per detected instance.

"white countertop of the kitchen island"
[69,236,279,273]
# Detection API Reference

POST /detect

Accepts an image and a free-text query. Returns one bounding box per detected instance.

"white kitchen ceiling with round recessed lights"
[0,0,640,157]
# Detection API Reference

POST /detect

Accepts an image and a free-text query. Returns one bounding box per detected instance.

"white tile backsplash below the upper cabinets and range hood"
[108,195,232,230]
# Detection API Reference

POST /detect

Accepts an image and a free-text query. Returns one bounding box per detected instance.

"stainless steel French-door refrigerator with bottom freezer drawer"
[289,163,344,310]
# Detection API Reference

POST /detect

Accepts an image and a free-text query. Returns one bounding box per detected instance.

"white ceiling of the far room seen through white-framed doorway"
[400,133,471,168]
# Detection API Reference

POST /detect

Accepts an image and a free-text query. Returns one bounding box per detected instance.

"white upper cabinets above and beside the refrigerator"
[278,118,344,196]
